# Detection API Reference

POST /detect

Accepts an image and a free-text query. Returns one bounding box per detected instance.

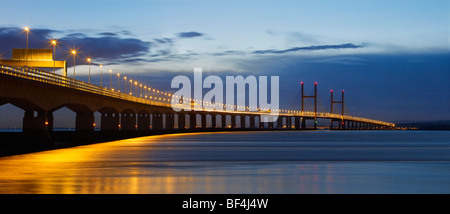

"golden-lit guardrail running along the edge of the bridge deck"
[0,64,395,127]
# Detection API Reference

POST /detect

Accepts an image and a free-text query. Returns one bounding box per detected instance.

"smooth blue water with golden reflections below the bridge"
[0,131,450,194]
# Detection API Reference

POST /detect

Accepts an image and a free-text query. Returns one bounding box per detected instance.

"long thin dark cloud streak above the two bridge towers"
[252,43,366,54]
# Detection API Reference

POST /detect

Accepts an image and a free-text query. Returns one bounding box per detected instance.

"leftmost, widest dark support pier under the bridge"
[22,111,50,132]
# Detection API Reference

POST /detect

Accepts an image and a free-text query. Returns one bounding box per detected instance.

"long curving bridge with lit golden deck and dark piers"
[0,64,395,135]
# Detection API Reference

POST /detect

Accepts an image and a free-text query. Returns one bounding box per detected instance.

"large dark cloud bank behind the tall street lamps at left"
[0,27,152,64]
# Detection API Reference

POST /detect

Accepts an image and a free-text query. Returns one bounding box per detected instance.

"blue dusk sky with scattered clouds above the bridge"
[0,0,450,125]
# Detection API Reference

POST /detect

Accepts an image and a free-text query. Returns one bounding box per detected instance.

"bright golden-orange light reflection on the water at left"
[0,136,183,194]
